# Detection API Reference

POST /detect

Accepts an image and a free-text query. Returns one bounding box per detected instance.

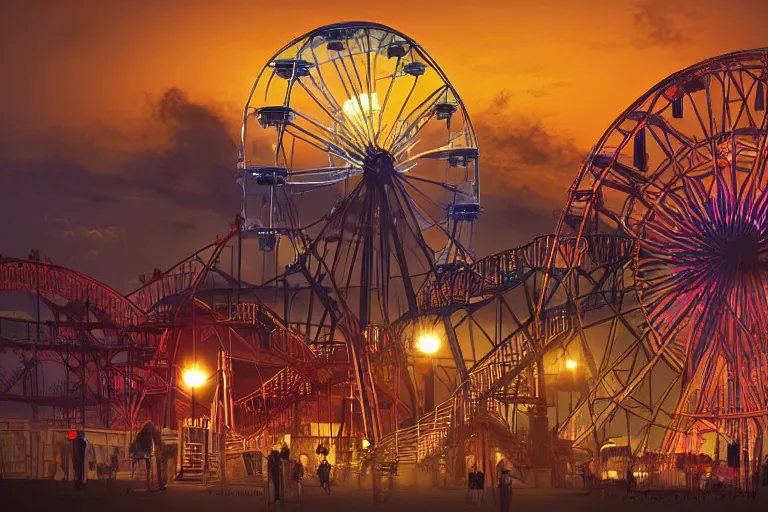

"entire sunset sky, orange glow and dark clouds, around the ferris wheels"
[0,0,768,291]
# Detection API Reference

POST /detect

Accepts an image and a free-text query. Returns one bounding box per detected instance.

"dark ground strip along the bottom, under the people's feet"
[0,480,768,512]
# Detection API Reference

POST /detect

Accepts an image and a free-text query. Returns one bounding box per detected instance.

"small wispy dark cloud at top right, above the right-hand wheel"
[633,0,694,50]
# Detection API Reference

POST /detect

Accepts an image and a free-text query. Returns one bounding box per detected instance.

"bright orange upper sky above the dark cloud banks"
[6,0,768,142]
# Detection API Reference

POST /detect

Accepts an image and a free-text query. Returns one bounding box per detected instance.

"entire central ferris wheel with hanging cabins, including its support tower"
[238,22,481,439]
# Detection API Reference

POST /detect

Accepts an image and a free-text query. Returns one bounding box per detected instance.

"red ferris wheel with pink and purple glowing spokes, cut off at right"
[539,49,768,461]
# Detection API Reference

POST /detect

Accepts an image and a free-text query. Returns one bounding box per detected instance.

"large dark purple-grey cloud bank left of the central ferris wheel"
[0,89,239,290]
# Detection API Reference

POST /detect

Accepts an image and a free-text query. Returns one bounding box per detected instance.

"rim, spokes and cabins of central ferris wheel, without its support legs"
[239,22,480,263]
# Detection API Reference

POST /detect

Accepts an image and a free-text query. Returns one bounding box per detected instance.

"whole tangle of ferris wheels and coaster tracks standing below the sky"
[0,23,768,496]
